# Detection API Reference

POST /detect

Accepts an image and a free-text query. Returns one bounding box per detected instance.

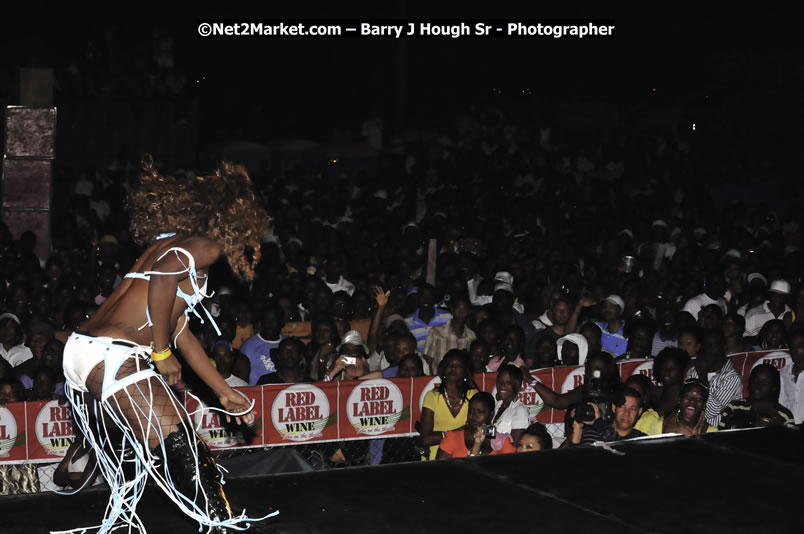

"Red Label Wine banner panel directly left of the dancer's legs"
[25,400,75,461]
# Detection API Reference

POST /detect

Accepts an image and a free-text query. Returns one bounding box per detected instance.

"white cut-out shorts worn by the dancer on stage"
[63,332,156,400]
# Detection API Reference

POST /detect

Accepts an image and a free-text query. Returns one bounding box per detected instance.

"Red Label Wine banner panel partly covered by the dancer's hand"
[184,386,264,450]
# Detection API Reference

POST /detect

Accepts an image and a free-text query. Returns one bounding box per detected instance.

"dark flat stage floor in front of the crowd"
[6,429,804,534]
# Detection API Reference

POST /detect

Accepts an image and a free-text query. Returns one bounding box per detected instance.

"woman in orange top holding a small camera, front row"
[436,391,516,460]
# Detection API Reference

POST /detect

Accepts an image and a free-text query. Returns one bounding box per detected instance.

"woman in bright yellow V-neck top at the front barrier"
[416,349,478,460]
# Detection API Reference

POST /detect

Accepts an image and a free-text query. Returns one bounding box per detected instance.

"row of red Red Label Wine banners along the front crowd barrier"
[0,350,792,463]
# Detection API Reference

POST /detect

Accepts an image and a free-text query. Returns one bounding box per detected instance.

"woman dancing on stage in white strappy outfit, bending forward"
[58,156,269,533]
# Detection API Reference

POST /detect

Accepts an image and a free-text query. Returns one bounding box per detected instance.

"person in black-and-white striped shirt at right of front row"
[687,330,743,427]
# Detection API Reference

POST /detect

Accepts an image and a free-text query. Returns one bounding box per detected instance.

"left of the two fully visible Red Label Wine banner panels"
[262,382,340,445]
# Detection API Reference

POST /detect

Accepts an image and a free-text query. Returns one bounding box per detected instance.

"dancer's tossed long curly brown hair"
[128,154,271,280]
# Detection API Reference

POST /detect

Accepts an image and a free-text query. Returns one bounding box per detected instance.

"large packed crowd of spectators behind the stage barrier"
[0,104,804,490]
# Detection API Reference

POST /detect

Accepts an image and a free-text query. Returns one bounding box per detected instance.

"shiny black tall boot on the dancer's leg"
[154,430,232,534]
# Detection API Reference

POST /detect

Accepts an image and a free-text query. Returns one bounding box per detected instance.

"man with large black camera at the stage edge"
[570,388,645,447]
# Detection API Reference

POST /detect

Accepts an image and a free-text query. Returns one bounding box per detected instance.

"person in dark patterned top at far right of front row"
[718,363,795,430]
